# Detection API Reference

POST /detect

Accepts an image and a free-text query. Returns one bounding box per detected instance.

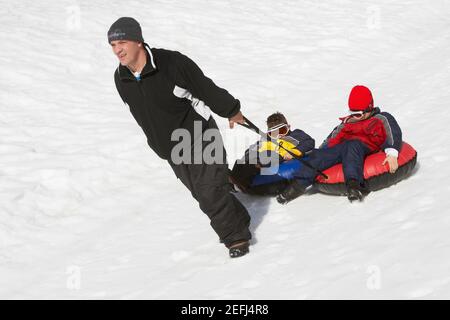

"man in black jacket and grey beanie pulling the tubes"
[108,17,251,258]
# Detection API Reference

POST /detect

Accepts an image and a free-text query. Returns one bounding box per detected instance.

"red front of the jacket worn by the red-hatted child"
[328,117,387,152]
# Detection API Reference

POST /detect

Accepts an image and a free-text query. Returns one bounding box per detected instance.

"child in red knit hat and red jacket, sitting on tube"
[277,86,402,204]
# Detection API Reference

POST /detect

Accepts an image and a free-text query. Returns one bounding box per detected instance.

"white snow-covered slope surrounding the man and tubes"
[0,0,450,299]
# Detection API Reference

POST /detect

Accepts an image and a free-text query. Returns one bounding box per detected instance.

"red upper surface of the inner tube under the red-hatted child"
[316,142,417,184]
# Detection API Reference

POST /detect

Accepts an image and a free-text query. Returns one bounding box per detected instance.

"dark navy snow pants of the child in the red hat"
[295,140,370,187]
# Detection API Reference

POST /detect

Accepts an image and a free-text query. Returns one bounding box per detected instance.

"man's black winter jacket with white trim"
[114,44,240,159]
